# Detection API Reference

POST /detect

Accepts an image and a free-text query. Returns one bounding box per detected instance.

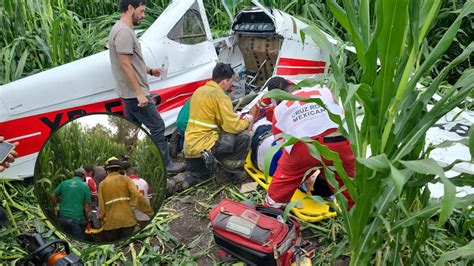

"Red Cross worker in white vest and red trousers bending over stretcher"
[265,86,355,209]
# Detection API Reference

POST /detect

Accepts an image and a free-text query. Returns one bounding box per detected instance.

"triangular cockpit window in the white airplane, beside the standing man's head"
[168,9,206,44]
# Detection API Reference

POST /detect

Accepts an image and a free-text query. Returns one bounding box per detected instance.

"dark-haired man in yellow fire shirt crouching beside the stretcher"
[167,63,253,195]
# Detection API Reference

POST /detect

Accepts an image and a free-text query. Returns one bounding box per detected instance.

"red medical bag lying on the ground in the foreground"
[209,199,314,265]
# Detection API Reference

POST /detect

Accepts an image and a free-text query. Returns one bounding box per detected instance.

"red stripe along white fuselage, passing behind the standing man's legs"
[0,80,207,157]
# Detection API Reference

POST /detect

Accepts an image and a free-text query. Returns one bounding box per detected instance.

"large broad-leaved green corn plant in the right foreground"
[269,0,474,265]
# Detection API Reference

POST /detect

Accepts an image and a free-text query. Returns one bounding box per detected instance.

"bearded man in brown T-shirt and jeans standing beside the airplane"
[108,0,184,172]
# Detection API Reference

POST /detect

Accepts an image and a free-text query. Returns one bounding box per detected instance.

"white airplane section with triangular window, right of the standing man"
[141,0,218,129]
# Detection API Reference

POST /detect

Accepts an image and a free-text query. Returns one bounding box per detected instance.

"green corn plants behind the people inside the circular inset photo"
[35,119,166,225]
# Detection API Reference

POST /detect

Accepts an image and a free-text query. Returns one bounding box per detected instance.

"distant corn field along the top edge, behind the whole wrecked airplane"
[0,0,473,84]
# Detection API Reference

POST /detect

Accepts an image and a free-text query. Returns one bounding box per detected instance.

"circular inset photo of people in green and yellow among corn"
[34,114,166,244]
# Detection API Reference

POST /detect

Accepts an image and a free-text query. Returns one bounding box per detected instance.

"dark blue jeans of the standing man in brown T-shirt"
[122,96,170,165]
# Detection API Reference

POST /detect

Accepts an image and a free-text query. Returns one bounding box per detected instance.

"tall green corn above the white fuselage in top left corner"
[0,0,169,84]
